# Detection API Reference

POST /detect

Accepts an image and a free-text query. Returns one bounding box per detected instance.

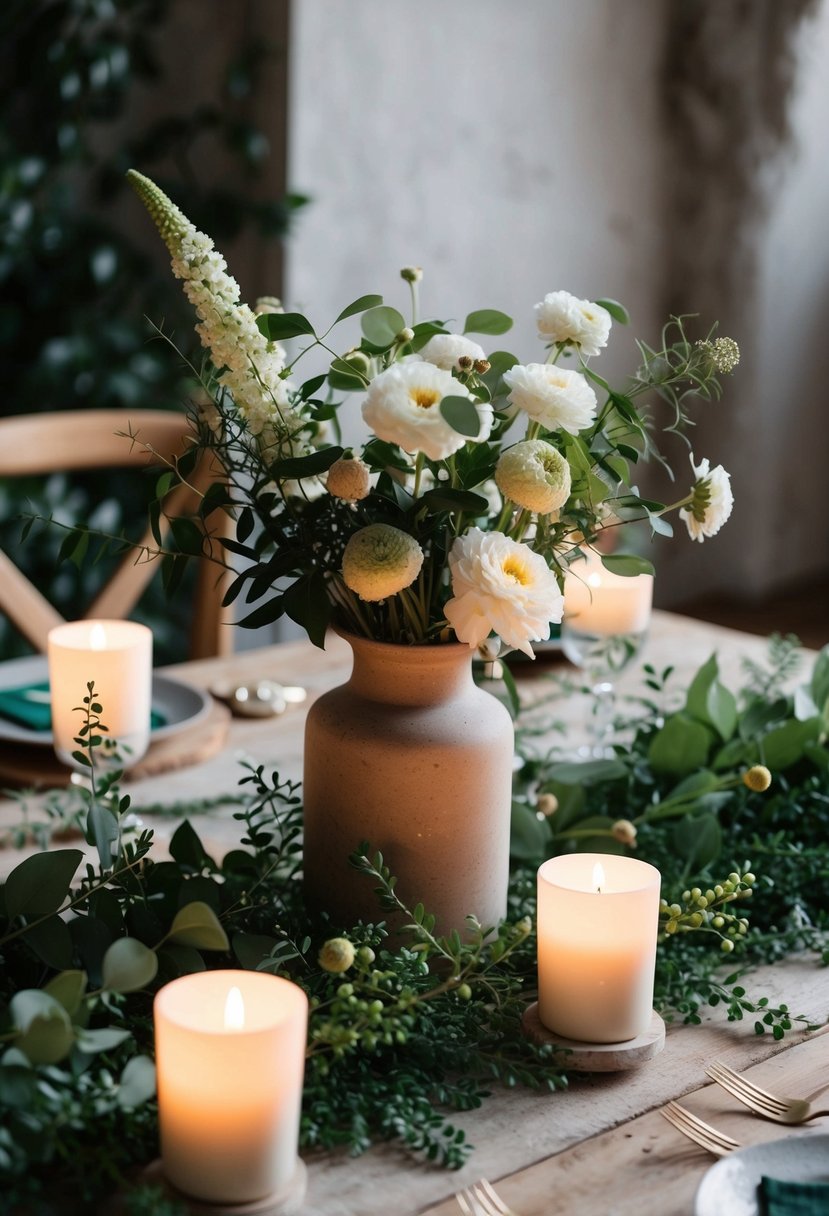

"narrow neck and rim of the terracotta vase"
[344,634,473,705]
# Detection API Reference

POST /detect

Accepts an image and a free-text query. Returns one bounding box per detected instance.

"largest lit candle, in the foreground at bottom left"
[153,970,308,1204]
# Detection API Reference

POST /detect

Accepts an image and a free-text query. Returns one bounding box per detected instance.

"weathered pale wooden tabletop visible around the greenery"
[0,613,829,1216]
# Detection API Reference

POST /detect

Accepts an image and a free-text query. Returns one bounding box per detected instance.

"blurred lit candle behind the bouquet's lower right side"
[564,552,654,637]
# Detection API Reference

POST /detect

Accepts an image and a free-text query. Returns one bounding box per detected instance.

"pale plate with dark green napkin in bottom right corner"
[694,1133,829,1216]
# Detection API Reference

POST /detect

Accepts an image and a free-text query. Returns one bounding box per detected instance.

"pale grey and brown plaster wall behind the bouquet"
[284,0,829,604]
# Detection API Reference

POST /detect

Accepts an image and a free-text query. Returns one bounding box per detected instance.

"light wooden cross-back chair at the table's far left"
[0,410,232,658]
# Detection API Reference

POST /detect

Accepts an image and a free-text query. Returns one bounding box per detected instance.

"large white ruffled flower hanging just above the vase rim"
[445,528,564,658]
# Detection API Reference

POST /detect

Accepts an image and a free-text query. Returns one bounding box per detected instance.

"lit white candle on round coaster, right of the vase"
[538,852,660,1043]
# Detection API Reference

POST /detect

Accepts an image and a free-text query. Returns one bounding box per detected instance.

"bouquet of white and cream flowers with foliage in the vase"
[129,171,739,657]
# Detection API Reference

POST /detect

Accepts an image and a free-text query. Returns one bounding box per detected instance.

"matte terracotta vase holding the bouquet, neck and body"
[304,635,514,933]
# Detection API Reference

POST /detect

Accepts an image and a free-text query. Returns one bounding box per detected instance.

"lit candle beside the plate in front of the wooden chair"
[49,620,152,764]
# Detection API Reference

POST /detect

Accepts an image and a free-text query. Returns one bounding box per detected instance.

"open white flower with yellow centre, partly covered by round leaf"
[362,360,492,460]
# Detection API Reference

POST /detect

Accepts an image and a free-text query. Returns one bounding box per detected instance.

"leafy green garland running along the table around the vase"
[0,638,829,1216]
